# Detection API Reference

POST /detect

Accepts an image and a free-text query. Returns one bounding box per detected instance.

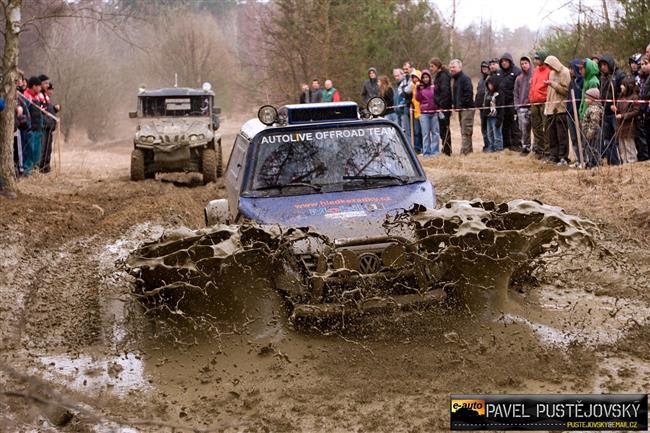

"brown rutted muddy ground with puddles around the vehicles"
[0,115,650,432]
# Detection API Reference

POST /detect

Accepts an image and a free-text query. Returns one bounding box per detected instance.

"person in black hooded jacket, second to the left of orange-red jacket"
[499,53,521,151]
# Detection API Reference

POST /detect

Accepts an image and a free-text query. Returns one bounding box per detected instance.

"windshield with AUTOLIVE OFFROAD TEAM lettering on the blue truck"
[248,125,421,195]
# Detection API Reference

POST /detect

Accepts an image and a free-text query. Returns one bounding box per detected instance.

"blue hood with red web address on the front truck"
[239,181,435,240]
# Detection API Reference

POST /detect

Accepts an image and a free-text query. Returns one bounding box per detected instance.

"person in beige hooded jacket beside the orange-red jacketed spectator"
[544,56,571,166]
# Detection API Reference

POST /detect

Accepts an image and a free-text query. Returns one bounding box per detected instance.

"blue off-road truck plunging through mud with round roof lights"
[205,98,442,317]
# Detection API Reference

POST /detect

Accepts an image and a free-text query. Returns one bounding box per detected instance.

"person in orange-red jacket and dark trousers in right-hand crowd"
[528,51,551,159]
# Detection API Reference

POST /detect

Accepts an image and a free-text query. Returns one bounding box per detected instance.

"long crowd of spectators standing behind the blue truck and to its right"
[300,45,650,168]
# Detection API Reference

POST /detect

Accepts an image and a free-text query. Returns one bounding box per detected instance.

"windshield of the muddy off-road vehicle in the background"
[140,96,211,117]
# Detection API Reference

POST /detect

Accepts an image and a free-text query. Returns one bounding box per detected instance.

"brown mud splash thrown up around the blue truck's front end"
[127,200,597,320]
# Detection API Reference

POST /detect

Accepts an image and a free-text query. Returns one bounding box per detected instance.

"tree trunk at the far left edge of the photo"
[0,0,22,191]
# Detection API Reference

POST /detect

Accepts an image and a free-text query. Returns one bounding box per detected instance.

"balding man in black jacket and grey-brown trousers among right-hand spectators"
[449,59,474,155]
